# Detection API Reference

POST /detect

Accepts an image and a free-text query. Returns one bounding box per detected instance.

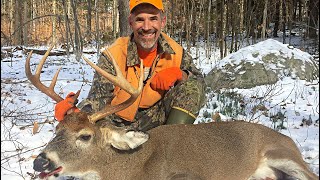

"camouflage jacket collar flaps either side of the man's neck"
[127,33,175,66]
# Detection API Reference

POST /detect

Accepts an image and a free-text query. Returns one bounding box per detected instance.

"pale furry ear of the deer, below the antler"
[110,131,149,150]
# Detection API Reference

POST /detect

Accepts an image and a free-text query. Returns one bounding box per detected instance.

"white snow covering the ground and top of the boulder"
[1,39,319,180]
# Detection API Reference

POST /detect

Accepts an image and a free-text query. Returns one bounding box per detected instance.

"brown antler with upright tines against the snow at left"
[25,45,63,102]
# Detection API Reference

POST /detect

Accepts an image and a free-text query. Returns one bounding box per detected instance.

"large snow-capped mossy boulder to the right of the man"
[205,39,319,90]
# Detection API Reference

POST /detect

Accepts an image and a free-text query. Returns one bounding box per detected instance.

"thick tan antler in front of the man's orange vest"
[82,49,143,123]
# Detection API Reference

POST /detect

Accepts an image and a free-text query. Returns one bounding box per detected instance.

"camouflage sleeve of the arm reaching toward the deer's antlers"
[78,53,115,113]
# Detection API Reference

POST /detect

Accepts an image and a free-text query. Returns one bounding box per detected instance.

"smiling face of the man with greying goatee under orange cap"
[129,4,166,51]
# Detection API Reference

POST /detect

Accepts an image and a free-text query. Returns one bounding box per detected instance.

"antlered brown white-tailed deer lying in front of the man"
[26,48,318,180]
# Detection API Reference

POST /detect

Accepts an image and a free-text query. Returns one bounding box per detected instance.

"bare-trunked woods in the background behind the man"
[1,0,319,58]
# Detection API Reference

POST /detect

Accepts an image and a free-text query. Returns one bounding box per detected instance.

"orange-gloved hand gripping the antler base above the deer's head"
[54,92,80,122]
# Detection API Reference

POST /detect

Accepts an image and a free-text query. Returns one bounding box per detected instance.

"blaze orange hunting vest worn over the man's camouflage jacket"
[102,33,183,121]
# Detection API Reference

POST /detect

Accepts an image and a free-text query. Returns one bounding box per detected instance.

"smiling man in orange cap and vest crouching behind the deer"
[55,0,205,131]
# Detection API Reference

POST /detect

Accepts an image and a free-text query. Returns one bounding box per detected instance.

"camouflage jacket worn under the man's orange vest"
[78,35,204,113]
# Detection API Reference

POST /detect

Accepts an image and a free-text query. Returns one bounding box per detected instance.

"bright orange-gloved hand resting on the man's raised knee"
[150,67,182,91]
